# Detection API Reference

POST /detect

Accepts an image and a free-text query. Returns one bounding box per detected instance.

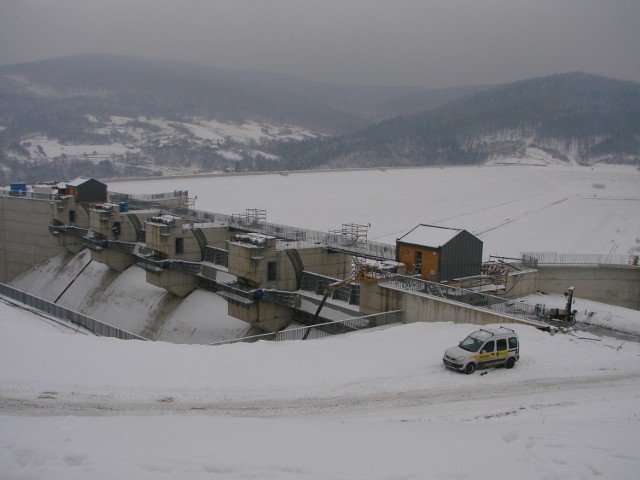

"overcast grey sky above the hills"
[0,0,640,88]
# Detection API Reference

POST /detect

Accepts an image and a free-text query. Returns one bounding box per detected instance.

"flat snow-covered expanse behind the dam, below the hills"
[108,160,640,259]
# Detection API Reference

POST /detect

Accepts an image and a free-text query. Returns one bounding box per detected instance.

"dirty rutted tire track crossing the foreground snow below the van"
[0,373,640,417]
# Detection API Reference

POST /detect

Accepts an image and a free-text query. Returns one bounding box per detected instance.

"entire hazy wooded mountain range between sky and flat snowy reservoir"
[0,55,640,184]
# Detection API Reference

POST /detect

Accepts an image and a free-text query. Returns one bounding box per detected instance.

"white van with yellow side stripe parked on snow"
[442,326,520,374]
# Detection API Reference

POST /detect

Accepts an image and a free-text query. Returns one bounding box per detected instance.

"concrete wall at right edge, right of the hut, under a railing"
[538,265,640,310]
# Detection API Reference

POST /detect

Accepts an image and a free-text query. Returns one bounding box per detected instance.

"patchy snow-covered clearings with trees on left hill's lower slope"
[13,116,319,175]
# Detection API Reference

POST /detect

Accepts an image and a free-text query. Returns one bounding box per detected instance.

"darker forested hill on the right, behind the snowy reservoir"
[281,73,640,168]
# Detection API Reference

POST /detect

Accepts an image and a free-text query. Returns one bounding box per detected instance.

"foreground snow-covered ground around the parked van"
[0,302,640,480]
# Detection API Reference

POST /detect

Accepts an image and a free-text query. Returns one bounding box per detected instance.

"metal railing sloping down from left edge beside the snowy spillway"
[0,283,146,340]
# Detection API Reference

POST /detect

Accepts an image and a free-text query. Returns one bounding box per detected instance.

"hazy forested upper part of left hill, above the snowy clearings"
[0,54,485,134]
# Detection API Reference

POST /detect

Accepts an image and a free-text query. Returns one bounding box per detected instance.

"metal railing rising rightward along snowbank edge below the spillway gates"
[209,310,402,346]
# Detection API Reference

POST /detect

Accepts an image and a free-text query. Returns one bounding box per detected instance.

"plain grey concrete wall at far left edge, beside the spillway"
[0,196,66,283]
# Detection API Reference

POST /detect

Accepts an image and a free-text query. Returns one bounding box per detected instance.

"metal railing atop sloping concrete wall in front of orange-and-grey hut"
[379,275,546,326]
